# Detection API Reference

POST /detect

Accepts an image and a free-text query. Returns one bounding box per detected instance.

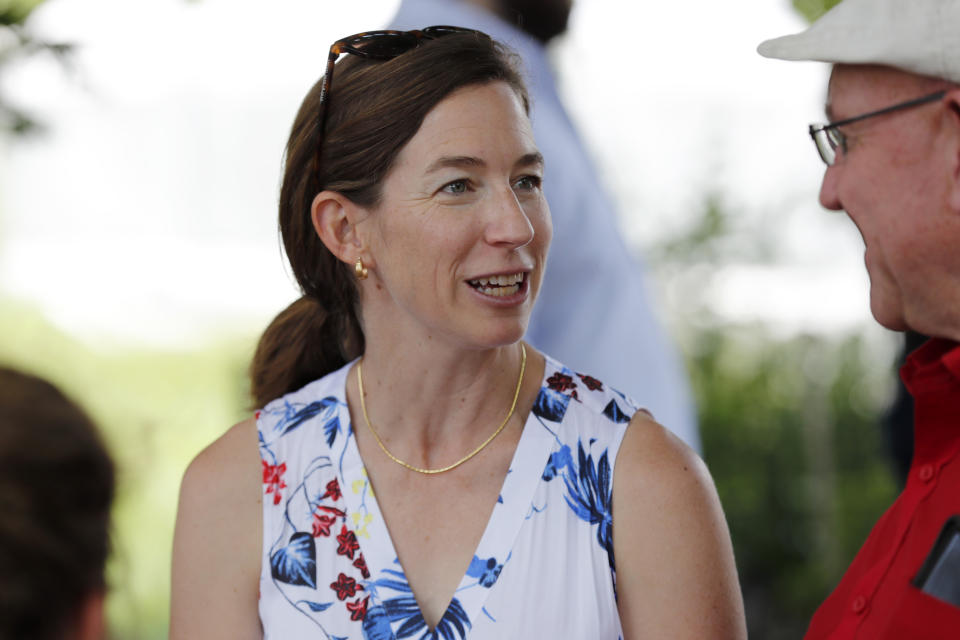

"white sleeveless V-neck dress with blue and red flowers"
[257,358,637,640]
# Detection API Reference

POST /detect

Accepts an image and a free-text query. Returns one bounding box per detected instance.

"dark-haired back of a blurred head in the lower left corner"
[0,367,114,640]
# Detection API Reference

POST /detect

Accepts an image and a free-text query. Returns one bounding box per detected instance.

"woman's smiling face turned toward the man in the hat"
[361,82,553,348]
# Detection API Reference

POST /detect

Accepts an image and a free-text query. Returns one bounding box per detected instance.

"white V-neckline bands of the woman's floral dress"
[335,357,555,638]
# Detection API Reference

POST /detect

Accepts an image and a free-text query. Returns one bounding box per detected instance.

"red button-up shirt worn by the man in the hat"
[805,339,960,640]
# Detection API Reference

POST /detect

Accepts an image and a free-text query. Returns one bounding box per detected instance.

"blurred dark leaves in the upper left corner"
[0,0,73,135]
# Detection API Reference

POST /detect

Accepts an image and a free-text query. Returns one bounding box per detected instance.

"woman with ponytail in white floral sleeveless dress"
[171,27,745,640]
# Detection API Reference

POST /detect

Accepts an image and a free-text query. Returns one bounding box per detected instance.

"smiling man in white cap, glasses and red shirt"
[759,0,960,639]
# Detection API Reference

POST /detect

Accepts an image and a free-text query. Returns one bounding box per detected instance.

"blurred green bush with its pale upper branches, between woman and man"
[647,189,897,640]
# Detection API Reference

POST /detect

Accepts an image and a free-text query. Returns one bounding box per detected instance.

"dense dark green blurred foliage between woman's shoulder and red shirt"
[688,326,896,639]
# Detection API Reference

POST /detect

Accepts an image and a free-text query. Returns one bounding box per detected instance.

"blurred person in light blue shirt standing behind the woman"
[391,0,700,451]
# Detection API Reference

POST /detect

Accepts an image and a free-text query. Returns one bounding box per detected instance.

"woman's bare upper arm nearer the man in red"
[613,412,747,640]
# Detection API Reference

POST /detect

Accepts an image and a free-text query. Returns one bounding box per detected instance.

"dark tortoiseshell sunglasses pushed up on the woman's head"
[317,25,482,140]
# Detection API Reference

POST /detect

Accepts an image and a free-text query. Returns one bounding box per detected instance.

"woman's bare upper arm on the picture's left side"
[170,420,263,640]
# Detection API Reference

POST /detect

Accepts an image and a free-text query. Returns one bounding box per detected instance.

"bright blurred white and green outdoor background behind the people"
[0,0,901,639]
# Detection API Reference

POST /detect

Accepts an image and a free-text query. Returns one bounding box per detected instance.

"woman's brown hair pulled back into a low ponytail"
[250,28,529,406]
